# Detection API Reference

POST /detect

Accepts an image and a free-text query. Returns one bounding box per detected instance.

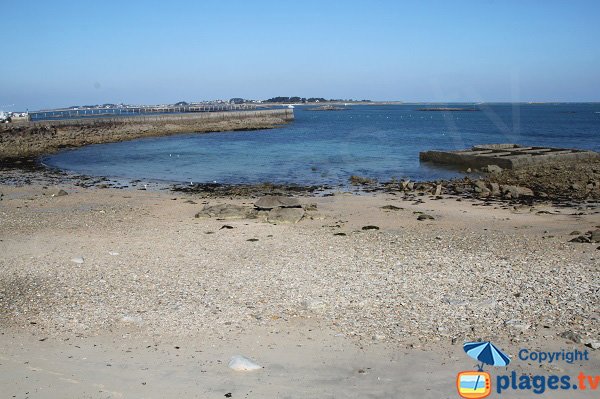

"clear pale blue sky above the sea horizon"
[0,0,600,111]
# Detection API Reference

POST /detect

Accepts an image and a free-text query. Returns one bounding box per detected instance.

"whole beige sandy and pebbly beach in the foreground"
[0,172,600,398]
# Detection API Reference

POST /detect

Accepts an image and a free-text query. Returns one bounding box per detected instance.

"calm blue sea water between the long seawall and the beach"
[44,104,600,185]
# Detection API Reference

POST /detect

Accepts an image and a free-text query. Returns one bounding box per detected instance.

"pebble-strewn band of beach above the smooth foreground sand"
[0,185,600,345]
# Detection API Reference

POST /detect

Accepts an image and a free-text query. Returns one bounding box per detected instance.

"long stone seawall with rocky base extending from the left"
[0,109,294,162]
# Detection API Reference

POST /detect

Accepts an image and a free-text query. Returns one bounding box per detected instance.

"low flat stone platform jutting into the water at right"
[419,144,600,169]
